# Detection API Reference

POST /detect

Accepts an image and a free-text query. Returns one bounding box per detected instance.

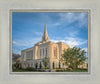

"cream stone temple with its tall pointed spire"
[21,20,69,69]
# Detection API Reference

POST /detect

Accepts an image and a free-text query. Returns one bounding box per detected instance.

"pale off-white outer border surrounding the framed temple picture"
[0,0,100,84]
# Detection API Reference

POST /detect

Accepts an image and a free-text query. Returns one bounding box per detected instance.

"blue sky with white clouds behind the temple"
[12,12,88,54]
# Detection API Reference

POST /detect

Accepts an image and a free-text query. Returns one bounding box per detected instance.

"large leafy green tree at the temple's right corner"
[61,47,86,72]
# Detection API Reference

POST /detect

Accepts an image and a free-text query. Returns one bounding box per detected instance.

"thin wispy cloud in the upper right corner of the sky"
[59,13,87,27]
